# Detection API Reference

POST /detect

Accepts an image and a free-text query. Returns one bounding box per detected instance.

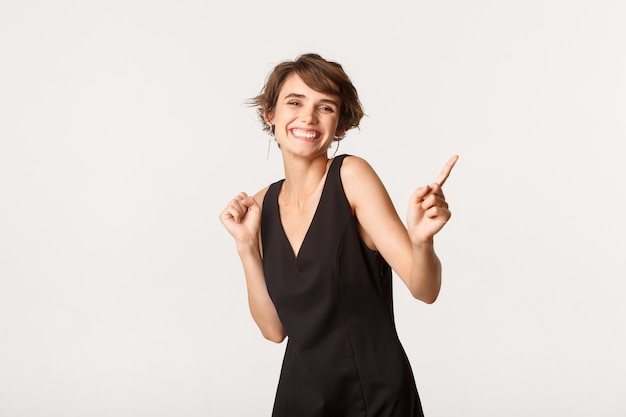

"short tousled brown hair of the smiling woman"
[248,54,365,140]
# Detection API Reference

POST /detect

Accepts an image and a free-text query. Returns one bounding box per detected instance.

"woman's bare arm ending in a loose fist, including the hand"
[220,190,285,343]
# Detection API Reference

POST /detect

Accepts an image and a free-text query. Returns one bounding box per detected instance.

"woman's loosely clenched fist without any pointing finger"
[220,192,261,243]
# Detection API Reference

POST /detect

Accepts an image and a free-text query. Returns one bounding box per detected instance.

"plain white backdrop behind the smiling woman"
[0,0,626,417]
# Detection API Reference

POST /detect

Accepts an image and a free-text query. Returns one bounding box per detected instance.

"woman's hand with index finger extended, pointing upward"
[407,155,459,244]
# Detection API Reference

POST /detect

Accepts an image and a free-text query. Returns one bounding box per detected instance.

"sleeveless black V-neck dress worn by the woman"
[261,155,423,417]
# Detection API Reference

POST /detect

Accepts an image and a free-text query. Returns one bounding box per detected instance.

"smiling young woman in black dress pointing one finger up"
[220,54,457,417]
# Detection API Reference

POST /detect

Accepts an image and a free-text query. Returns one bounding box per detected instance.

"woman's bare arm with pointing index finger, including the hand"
[342,157,457,303]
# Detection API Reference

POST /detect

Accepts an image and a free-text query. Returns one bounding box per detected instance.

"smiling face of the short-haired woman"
[266,73,341,156]
